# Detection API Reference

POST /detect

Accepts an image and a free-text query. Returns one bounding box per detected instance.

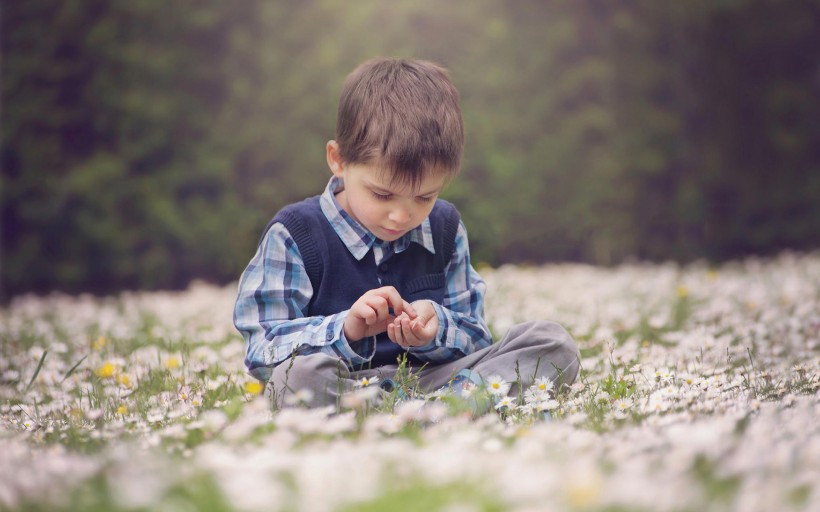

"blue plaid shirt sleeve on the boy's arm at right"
[409,222,493,364]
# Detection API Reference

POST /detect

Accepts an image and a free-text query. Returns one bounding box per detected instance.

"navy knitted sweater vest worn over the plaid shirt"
[265,196,460,368]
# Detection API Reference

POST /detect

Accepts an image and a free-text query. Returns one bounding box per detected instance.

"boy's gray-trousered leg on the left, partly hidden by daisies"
[269,353,380,407]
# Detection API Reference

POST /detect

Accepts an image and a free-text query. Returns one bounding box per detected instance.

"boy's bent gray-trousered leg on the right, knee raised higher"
[419,320,580,396]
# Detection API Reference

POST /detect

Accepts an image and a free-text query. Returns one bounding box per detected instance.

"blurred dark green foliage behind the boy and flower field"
[0,0,820,297]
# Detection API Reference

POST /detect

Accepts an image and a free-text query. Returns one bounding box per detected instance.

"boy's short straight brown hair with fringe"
[336,58,464,186]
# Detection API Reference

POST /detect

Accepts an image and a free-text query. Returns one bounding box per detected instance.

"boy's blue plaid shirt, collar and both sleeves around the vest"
[234,177,492,381]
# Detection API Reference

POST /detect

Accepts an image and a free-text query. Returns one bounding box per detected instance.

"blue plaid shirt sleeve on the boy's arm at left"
[233,223,375,381]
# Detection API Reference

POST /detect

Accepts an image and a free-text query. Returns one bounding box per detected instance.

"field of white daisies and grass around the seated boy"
[0,253,820,512]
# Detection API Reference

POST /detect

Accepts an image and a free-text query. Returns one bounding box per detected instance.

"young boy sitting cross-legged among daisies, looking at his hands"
[234,59,579,405]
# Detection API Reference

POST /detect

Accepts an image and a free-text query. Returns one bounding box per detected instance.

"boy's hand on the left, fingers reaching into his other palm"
[343,286,416,341]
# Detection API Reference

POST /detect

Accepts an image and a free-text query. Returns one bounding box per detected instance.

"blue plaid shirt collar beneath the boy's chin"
[319,176,436,260]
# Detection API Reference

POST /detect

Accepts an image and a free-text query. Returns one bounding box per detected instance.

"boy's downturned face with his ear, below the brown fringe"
[328,141,447,242]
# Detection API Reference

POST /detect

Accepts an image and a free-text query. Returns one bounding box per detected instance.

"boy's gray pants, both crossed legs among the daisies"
[270,321,580,407]
